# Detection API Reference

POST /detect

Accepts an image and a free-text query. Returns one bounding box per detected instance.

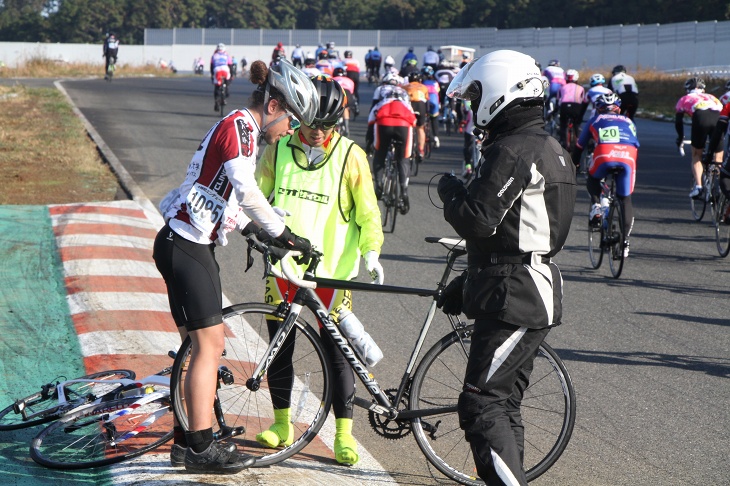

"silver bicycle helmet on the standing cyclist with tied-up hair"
[268,59,319,125]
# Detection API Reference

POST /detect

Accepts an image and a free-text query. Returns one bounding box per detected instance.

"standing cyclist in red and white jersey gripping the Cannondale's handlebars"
[152,60,319,474]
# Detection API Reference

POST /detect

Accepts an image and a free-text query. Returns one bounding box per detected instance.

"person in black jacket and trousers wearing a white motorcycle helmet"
[438,50,576,485]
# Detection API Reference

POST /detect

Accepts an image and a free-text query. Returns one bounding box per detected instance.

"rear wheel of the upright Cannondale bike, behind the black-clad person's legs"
[410,325,575,486]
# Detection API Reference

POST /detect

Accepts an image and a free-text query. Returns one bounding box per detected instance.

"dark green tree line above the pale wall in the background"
[0,0,730,44]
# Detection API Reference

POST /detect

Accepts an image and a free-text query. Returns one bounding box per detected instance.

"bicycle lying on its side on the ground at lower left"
[0,368,173,469]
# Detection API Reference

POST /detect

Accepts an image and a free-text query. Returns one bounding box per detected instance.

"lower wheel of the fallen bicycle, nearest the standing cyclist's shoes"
[30,389,173,469]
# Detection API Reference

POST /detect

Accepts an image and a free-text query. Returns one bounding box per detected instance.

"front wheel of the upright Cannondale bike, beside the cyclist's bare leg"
[170,303,332,467]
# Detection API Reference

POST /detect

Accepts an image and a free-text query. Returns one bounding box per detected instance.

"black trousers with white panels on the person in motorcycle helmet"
[459,319,549,486]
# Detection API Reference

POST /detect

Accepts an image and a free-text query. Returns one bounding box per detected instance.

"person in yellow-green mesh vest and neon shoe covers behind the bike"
[256,75,384,465]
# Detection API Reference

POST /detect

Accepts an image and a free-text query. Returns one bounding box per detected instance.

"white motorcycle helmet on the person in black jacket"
[446,50,546,129]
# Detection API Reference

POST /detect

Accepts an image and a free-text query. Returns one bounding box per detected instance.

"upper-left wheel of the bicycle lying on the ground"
[0,370,135,430]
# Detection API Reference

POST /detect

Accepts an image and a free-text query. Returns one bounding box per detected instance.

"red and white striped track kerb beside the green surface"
[49,201,395,485]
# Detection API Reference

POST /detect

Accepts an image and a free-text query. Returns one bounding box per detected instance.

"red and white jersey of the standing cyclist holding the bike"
[162,109,284,246]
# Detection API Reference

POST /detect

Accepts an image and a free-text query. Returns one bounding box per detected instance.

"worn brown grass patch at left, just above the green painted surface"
[0,86,119,205]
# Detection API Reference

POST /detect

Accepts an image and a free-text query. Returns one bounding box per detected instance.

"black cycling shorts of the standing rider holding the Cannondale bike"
[152,225,223,332]
